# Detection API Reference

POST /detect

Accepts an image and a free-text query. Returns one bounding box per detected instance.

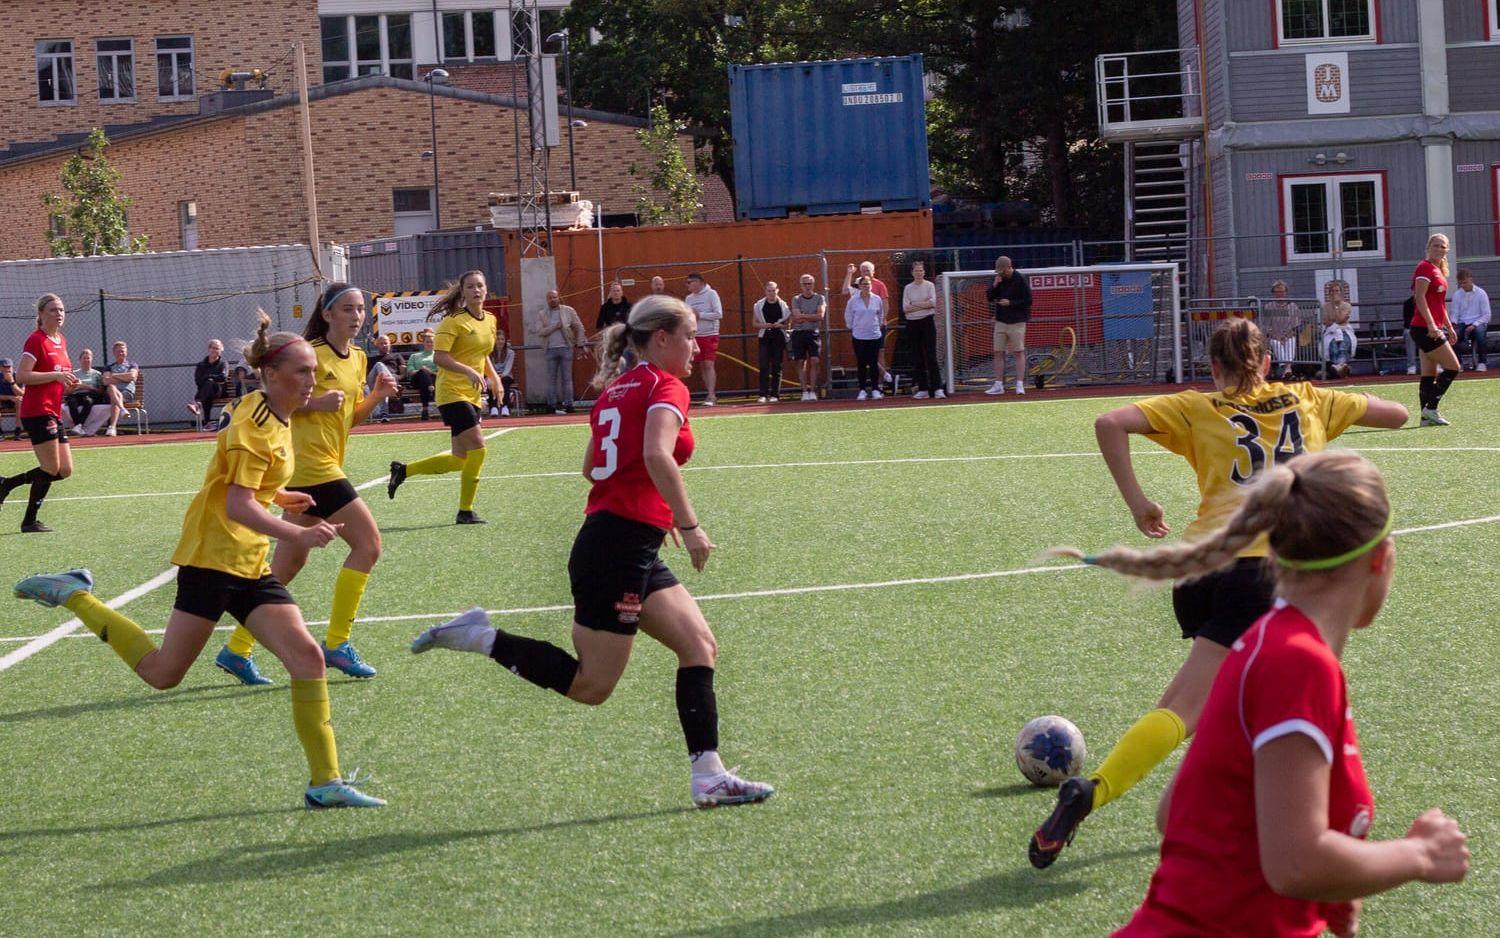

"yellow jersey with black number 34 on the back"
[1136,381,1370,557]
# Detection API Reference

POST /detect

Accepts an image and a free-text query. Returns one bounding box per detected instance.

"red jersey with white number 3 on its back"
[585,362,693,528]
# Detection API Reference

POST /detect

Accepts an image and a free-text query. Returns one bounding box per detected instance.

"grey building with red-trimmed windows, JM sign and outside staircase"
[1097,0,1500,324]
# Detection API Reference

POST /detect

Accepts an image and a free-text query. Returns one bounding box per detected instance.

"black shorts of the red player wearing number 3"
[567,512,678,635]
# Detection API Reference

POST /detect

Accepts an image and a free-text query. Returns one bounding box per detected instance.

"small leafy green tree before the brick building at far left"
[42,128,147,257]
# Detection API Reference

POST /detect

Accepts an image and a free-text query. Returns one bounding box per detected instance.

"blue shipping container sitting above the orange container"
[729,56,932,218]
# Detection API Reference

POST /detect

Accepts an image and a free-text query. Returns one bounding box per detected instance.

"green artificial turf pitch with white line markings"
[0,381,1500,935]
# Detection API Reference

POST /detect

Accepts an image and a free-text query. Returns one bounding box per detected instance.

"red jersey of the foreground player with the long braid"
[1115,602,1374,938]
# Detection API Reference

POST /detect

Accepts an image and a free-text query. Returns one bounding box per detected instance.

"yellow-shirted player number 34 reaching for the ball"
[1028,320,1407,869]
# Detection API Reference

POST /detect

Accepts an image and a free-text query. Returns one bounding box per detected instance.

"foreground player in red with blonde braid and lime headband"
[1086,453,1469,936]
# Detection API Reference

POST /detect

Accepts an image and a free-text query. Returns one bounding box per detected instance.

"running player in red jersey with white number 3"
[411,296,774,807]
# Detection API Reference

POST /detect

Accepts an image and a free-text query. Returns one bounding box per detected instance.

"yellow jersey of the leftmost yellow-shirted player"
[173,390,293,579]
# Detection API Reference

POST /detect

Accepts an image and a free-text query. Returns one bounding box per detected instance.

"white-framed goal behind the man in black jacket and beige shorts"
[938,261,1182,393]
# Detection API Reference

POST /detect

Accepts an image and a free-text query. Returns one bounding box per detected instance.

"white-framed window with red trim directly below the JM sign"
[1281,173,1388,261]
